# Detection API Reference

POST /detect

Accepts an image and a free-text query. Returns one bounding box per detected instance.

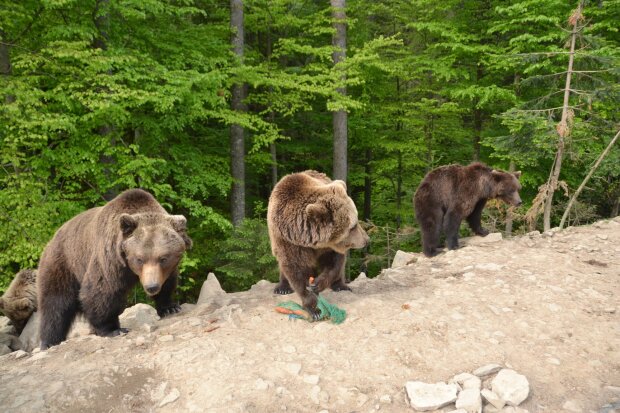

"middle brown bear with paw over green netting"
[267,171,368,319]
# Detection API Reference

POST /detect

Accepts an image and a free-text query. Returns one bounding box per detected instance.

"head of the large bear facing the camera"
[119,213,192,296]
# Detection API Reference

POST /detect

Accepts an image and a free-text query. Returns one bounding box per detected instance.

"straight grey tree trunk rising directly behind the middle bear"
[330,0,348,182]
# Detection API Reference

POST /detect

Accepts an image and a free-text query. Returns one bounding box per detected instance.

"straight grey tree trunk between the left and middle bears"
[230,0,246,226]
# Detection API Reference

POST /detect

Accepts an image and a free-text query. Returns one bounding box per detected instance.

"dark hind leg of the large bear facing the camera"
[38,264,79,350]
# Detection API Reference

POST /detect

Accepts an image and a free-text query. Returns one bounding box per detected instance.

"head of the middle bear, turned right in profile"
[305,180,369,254]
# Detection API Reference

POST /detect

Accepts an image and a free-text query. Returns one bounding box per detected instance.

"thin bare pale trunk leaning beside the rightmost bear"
[543,1,583,231]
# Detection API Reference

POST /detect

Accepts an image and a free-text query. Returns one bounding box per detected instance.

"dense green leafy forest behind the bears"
[0,0,620,301]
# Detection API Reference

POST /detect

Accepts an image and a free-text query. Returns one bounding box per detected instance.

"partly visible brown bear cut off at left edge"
[0,270,37,333]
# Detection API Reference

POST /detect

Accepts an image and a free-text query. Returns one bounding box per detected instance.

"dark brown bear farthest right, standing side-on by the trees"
[413,162,521,257]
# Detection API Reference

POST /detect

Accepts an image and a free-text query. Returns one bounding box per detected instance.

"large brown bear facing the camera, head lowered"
[37,189,192,349]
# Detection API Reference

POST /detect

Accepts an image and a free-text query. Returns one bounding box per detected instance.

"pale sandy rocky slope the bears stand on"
[0,218,620,413]
